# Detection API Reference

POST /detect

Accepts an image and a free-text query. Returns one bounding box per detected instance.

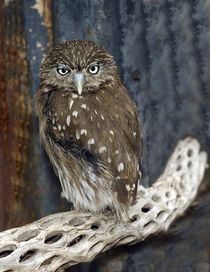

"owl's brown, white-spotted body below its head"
[43,84,141,218]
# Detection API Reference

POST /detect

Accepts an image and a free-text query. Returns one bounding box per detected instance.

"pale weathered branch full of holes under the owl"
[0,138,207,272]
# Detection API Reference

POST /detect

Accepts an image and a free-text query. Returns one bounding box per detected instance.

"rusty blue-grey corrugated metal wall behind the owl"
[0,0,210,272]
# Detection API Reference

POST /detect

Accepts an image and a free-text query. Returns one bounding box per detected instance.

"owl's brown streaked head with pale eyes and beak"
[40,40,120,95]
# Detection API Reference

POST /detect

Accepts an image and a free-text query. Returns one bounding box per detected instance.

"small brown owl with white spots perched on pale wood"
[36,40,142,220]
